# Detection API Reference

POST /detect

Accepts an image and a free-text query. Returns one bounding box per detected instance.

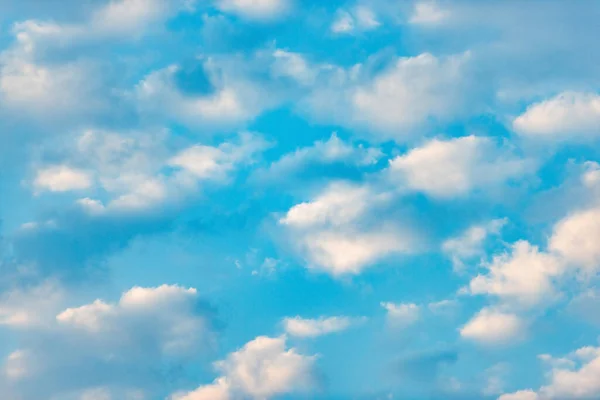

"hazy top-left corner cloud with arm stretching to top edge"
[0,0,192,118]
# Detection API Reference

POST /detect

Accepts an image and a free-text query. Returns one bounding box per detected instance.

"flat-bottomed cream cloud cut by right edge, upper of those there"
[513,92,600,141]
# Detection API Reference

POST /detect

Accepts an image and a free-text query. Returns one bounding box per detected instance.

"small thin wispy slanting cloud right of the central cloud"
[442,218,507,269]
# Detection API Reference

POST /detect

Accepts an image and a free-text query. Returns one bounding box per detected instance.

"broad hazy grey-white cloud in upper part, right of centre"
[301,53,474,141]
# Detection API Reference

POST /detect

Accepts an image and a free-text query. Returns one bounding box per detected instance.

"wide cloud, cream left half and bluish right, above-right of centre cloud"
[390,136,531,197]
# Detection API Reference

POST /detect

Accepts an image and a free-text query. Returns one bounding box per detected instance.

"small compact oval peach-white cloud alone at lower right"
[460,308,525,345]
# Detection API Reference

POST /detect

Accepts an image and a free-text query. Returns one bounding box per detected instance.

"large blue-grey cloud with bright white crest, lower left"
[1,285,214,399]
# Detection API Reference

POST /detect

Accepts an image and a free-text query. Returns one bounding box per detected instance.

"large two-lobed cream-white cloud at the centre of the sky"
[279,182,413,276]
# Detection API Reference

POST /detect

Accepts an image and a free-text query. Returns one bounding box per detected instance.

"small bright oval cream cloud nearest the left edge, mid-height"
[33,165,93,192]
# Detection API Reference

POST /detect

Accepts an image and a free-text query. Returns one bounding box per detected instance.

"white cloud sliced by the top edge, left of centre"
[216,0,292,22]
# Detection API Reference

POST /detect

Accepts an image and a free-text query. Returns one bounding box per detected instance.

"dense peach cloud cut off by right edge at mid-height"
[548,208,600,274]
